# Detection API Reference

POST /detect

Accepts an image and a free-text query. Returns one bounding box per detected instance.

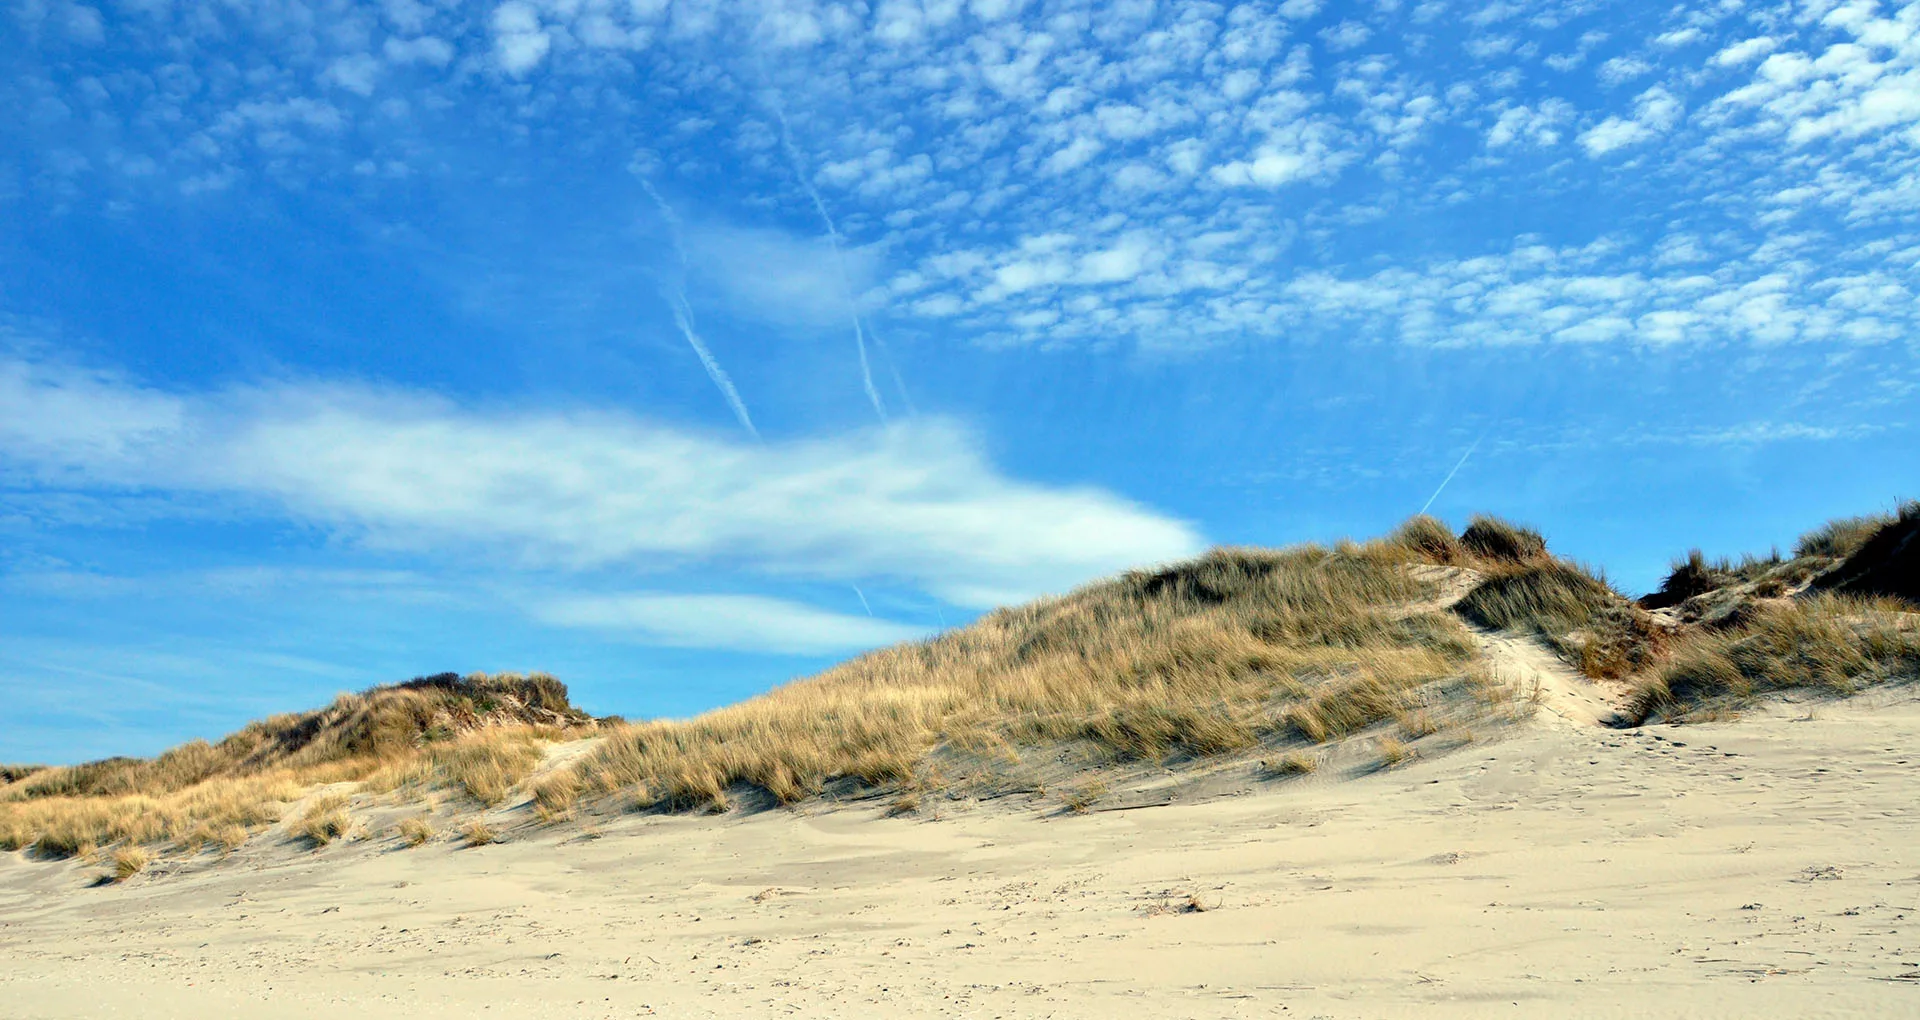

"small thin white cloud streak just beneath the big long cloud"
[528,592,925,655]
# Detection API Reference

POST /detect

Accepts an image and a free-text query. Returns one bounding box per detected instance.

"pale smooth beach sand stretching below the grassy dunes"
[0,695,1920,1020]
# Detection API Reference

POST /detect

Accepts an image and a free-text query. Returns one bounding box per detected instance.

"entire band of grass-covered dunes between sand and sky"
[0,503,1920,880]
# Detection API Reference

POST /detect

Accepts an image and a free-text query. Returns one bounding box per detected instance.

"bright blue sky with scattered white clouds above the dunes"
[0,0,1920,763]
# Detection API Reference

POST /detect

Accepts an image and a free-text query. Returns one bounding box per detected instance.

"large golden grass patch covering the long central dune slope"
[572,540,1475,811]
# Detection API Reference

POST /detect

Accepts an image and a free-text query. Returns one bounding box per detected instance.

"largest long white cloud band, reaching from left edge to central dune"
[0,361,1200,607]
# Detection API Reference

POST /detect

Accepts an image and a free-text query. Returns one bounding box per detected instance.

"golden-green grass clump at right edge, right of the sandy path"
[1632,594,1920,720]
